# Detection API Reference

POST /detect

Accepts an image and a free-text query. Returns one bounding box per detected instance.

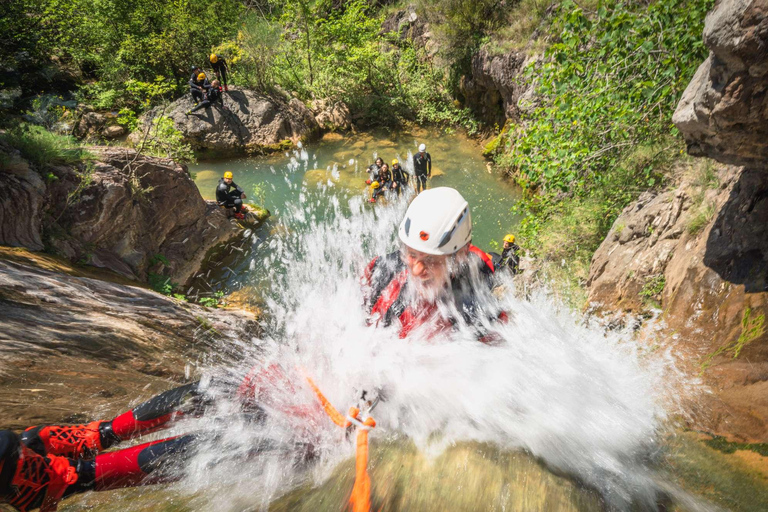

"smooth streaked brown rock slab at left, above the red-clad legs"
[0,248,258,429]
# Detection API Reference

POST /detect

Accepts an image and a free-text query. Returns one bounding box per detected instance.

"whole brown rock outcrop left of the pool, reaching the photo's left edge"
[0,148,248,285]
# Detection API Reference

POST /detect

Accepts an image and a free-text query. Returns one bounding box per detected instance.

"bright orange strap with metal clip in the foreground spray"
[307,377,376,512]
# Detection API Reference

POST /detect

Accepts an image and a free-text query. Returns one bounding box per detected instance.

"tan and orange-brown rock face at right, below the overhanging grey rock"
[588,167,768,443]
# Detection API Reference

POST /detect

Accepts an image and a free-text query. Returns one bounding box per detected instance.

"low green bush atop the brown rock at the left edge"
[2,124,93,171]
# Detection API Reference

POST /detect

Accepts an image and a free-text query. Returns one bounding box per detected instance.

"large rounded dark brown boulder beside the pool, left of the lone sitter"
[51,148,241,285]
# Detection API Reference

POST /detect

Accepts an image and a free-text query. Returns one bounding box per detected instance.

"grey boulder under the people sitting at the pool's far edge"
[134,89,319,153]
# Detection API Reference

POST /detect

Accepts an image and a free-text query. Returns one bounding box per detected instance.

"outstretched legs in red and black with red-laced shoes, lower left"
[0,376,322,512]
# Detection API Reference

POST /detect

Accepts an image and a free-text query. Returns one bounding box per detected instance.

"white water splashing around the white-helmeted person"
[147,177,680,510]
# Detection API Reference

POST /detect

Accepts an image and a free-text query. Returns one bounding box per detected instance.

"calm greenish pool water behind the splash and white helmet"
[190,129,520,296]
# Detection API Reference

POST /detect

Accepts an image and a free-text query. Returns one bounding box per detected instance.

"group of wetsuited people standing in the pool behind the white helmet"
[365,144,432,203]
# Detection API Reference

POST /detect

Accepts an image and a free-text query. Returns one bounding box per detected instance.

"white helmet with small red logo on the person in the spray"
[398,187,472,255]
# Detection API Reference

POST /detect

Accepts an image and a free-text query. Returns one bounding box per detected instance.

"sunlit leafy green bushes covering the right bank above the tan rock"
[496,0,712,300]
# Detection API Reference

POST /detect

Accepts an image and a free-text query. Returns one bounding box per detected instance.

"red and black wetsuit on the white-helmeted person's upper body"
[363,245,506,338]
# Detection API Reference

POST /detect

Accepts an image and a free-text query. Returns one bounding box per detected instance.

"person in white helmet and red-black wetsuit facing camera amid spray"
[363,187,507,342]
